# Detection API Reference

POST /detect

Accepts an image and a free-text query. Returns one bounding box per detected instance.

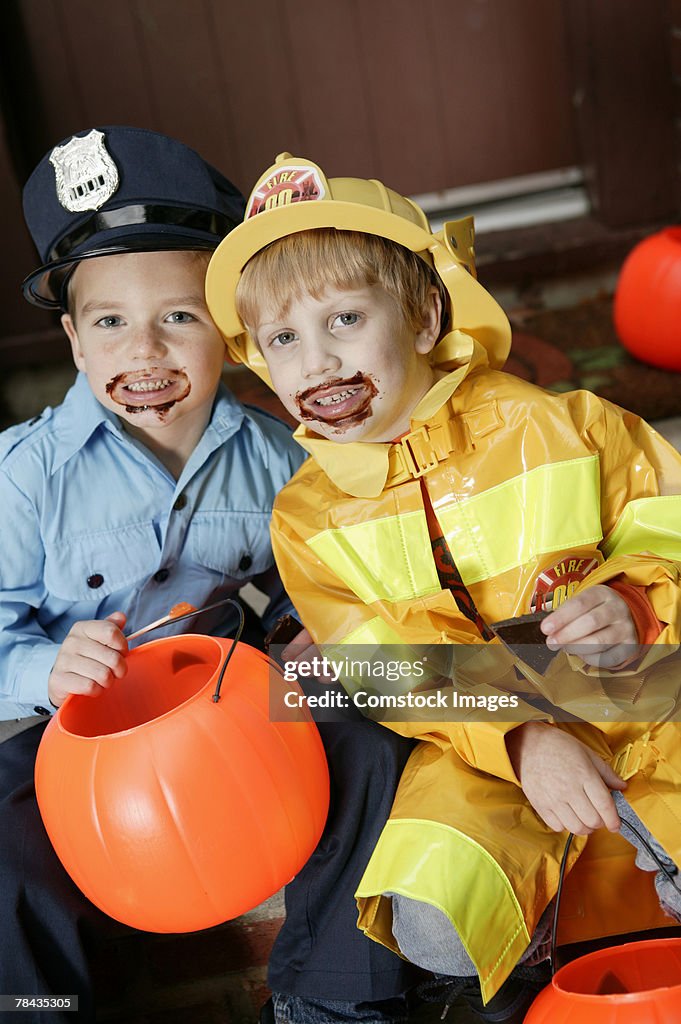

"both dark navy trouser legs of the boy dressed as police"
[0,696,420,1024]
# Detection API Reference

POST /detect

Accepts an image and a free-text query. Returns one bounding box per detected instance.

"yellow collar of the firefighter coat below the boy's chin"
[293,331,477,498]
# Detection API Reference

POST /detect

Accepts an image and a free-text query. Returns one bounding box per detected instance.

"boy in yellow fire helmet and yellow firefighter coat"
[207,154,681,1022]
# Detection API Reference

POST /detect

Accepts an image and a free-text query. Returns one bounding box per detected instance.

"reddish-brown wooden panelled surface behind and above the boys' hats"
[7,0,577,194]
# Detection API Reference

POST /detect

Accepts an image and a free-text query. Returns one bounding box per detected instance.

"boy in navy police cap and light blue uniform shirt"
[0,127,414,1024]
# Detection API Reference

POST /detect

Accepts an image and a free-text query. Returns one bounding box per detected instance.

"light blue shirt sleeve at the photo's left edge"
[0,471,59,719]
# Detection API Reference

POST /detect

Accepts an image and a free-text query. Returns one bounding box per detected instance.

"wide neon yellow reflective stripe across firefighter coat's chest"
[307,455,602,598]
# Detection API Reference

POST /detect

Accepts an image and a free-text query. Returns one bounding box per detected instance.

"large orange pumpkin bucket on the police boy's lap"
[36,634,329,932]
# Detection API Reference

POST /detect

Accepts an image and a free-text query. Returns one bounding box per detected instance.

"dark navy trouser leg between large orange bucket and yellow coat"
[267,681,421,1002]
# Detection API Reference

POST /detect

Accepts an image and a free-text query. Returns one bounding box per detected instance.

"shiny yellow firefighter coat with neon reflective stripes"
[272,332,681,999]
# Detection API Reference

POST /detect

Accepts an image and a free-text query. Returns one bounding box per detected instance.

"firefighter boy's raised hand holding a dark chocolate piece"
[541,586,638,669]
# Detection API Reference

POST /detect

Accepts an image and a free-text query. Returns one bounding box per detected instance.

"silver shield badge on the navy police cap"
[49,128,119,213]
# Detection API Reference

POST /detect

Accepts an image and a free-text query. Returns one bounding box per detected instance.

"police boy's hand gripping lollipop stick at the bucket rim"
[47,611,128,708]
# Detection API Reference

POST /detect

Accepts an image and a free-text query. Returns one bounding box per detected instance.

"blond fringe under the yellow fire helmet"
[236,227,442,331]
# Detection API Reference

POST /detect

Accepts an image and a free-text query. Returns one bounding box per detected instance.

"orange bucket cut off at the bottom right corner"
[524,938,681,1024]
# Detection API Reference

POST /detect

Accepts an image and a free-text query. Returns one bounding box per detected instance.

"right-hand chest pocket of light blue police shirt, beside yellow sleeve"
[187,511,274,582]
